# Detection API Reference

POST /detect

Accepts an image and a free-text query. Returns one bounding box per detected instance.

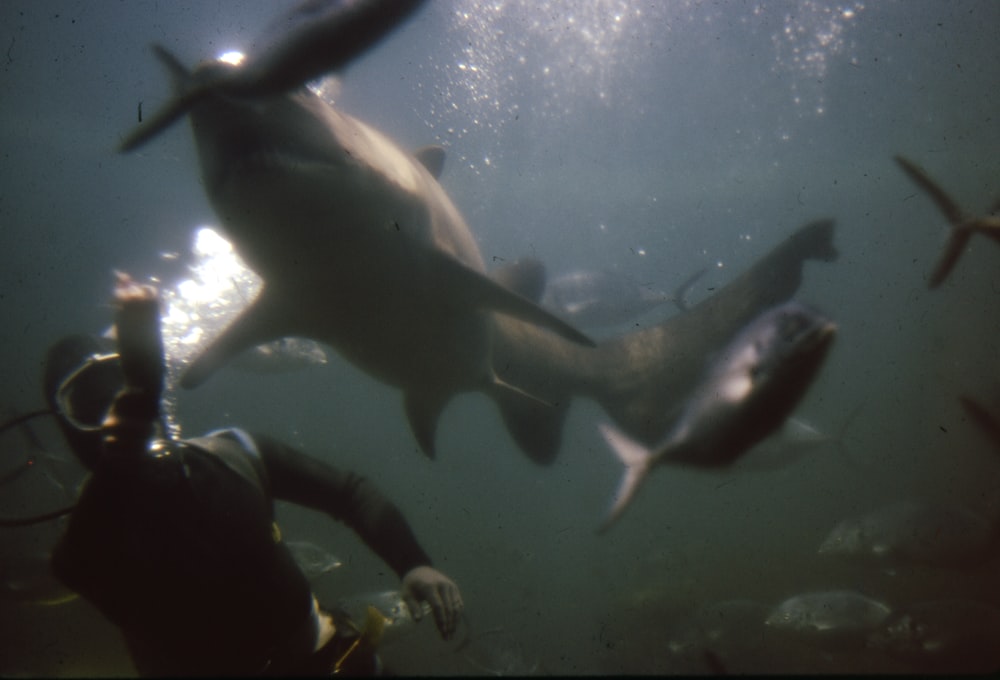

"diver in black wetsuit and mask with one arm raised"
[44,274,463,675]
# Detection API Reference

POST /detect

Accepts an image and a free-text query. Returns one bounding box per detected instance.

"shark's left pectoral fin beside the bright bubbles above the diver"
[181,286,296,389]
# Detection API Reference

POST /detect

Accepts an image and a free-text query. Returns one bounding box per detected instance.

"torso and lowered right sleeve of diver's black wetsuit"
[52,432,431,675]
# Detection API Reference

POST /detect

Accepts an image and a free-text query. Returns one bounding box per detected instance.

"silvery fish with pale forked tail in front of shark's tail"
[599,301,836,532]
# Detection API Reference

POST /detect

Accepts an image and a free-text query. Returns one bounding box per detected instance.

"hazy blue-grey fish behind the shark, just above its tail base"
[542,269,705,328]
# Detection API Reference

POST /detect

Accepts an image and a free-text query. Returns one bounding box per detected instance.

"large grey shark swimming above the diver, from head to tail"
[115,2,835,463]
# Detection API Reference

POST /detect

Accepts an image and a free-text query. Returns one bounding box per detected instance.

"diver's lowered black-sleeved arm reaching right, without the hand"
[253,434,431,578]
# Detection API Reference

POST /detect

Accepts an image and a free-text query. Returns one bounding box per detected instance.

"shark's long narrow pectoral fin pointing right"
[428,250,596,347]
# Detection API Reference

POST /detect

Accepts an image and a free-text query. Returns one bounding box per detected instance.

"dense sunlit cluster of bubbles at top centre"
[412,0,651,170]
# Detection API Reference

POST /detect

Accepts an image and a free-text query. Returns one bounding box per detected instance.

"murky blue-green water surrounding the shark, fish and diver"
[0,0,1000,675]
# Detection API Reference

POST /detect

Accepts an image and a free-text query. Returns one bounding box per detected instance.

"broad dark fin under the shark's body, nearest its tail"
[489,378,570,465]
